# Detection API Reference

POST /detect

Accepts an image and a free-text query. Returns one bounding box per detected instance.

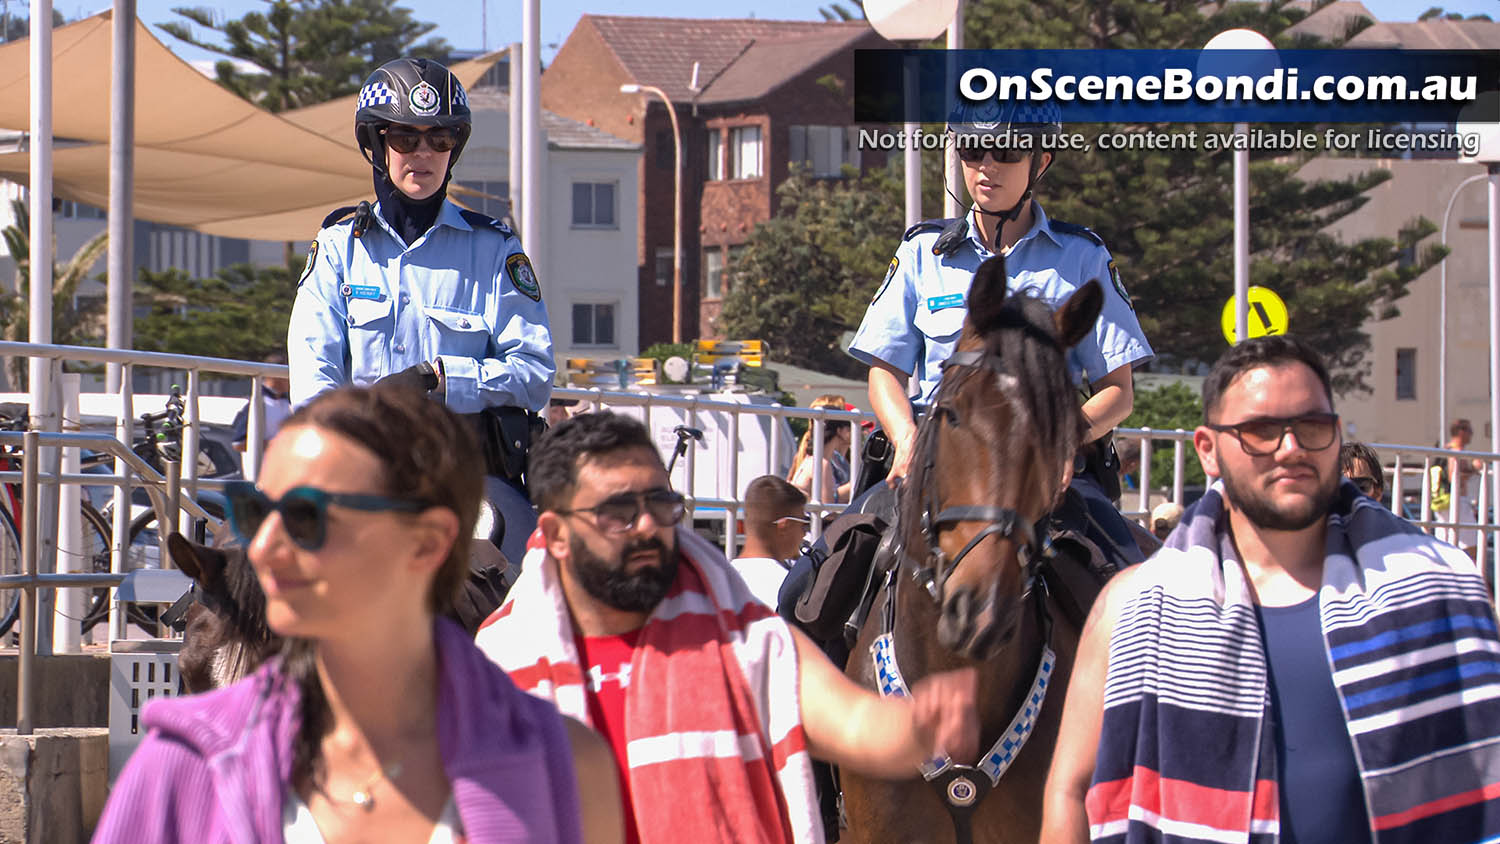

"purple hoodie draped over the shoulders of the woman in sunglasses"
[93,619,582,844]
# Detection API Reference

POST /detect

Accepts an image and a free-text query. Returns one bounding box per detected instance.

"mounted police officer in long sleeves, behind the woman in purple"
[287,58,557,561]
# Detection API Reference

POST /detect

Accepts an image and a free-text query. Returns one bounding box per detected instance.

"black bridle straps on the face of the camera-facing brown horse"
[903,349,1041,601]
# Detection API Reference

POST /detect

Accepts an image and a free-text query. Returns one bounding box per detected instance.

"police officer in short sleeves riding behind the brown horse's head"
[849,103,1152,560]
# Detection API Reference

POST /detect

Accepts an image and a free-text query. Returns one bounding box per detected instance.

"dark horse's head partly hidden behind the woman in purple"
[167,534,279,693]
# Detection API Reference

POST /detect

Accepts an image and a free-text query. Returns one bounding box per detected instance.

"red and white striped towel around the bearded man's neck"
[477,529,824,844]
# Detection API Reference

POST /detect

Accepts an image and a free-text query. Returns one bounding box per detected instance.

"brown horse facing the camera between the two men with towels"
[843,258,1103,844]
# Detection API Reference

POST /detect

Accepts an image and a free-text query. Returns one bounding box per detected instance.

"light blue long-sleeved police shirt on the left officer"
[287,201,557,414]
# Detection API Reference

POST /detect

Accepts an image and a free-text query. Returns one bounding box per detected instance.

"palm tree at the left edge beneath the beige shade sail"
[0,199,110,388]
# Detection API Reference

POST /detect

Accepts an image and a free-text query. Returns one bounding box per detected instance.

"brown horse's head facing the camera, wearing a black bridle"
[902,256,1104,660]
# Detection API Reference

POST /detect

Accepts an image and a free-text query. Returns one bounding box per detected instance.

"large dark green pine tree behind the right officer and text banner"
[744,0,1445,393]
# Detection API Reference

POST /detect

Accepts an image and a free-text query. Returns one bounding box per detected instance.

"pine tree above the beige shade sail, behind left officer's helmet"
[161,0,449,111]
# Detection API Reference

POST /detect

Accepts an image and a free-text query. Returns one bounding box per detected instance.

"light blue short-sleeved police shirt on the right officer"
[849,202,1154,406]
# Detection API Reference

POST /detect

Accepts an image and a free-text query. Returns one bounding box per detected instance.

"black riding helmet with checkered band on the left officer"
[354,58,473,177]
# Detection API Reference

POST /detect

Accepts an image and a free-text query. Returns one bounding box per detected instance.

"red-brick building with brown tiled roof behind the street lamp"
[542,15,891,348]
